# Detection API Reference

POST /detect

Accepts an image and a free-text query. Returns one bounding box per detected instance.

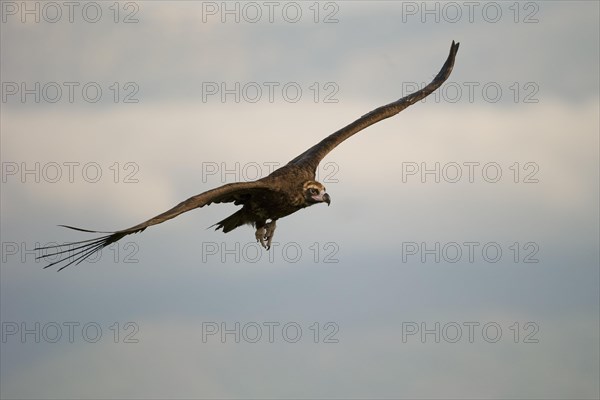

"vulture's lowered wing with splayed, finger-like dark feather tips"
[35,180,273,271]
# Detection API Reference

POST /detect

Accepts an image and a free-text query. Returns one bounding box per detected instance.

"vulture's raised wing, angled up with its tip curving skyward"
[288,41,459,173]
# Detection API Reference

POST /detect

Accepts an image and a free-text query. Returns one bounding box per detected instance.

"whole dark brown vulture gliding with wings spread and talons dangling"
[35,41,459,271]
